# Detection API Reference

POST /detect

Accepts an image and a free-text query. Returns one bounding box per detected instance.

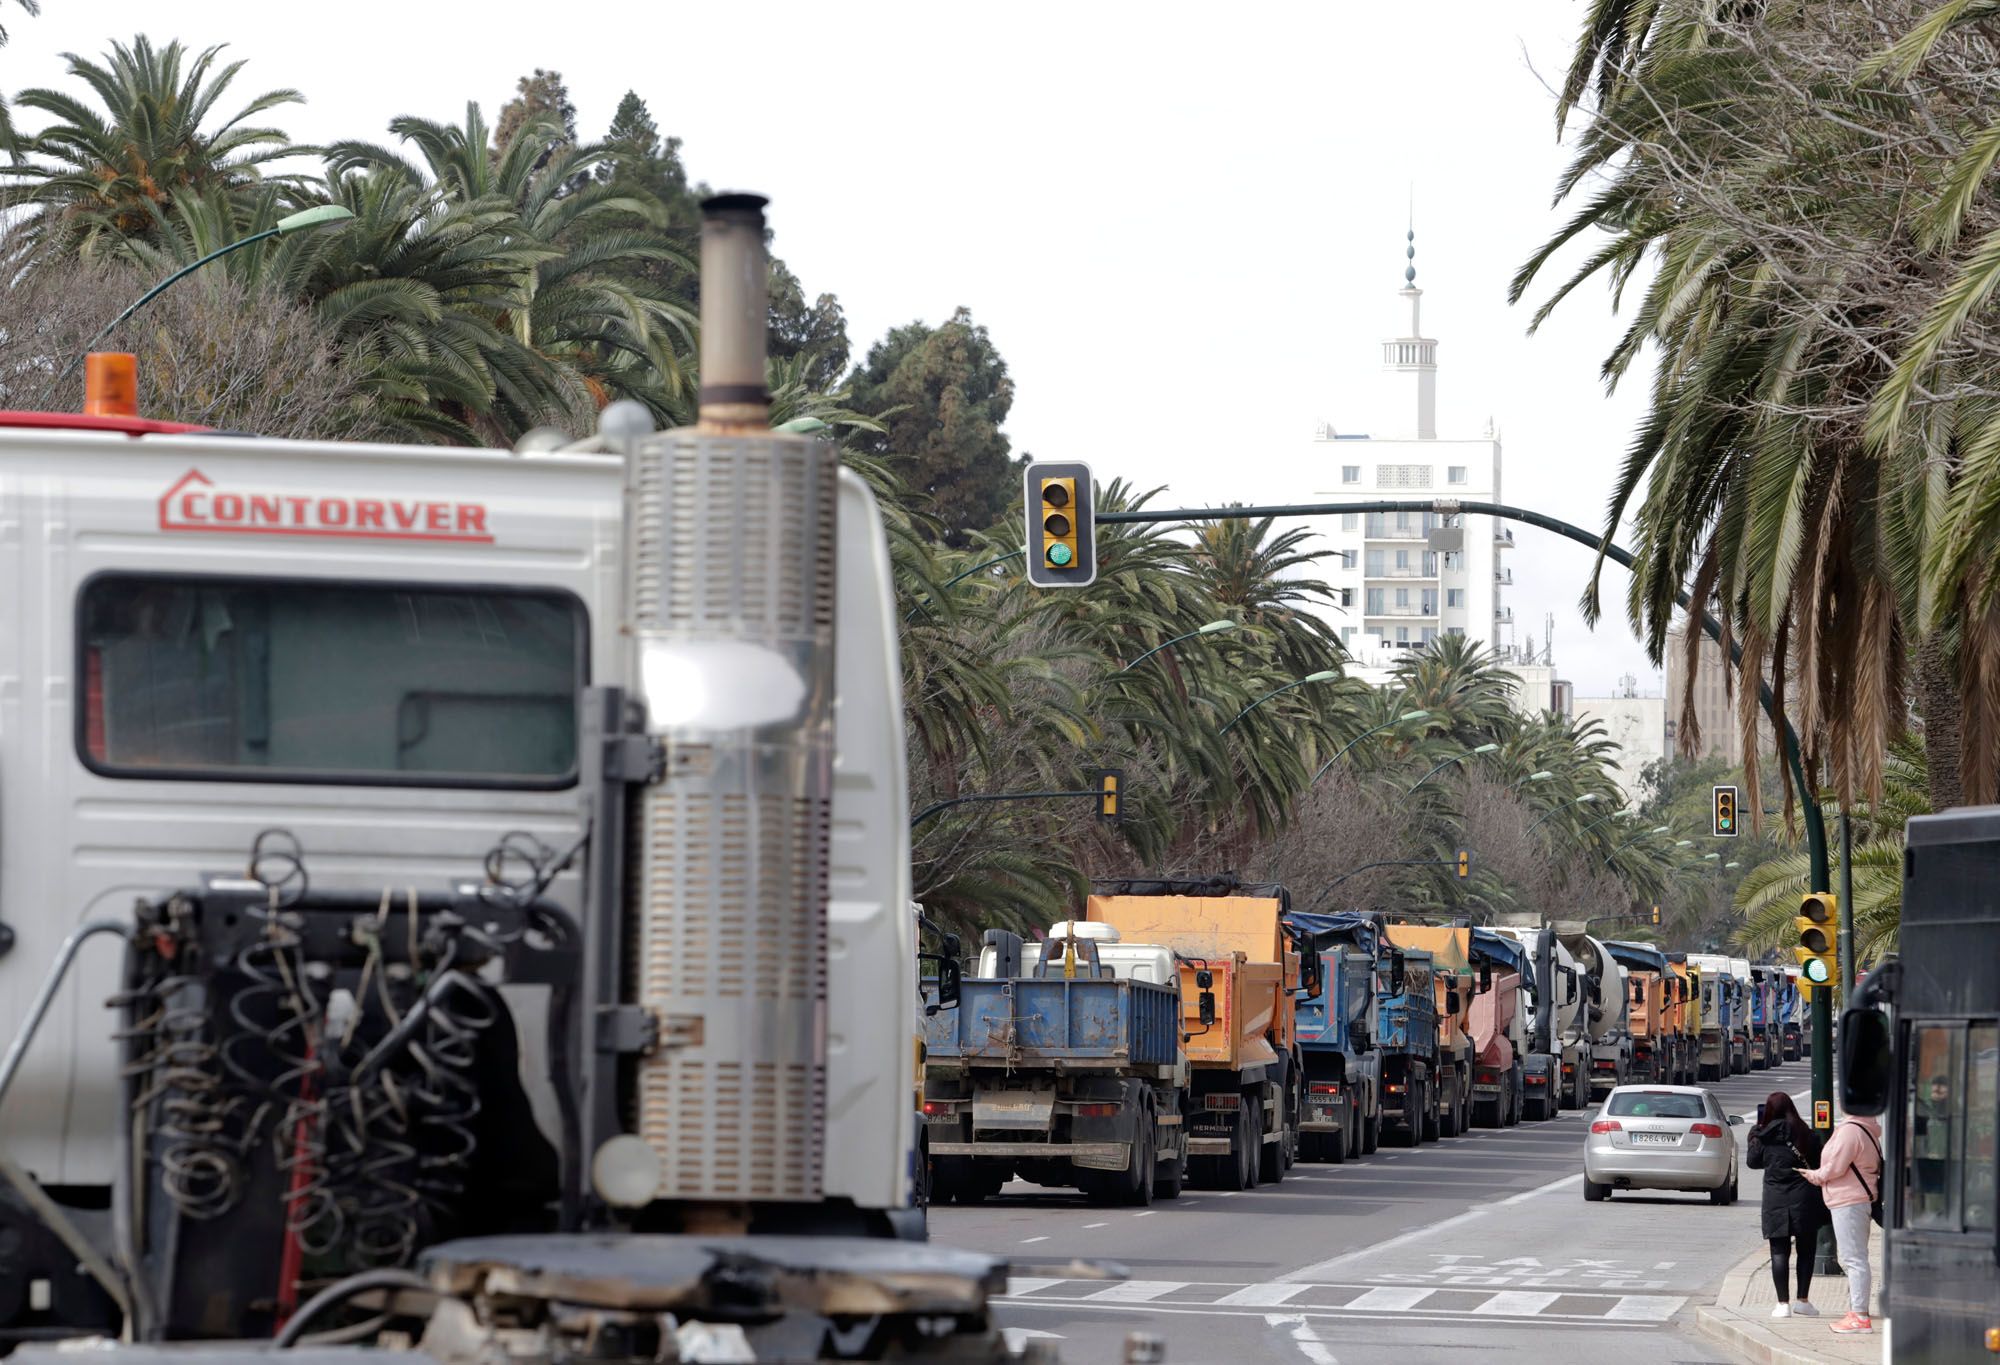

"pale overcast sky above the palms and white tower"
[11,0,1658,697]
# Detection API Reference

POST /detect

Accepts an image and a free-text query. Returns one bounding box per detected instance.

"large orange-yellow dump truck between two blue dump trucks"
[1086,877,1318,1189]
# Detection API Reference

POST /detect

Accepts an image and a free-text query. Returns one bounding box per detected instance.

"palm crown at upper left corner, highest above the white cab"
[0,34,306,252]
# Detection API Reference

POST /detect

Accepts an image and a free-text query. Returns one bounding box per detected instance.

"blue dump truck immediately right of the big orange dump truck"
[1284,913,1382,1161]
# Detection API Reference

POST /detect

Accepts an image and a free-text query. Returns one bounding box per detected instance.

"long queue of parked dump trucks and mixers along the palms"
[920,877,1804,1205]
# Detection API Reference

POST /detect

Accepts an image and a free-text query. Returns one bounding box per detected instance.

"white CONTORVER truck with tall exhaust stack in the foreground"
[0,186,1080,1361]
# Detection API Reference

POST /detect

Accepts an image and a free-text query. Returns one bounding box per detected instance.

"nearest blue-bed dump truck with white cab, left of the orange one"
[924,923,1206,1205]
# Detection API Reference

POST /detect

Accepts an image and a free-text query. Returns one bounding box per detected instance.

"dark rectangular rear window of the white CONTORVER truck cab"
[76,574,586,789]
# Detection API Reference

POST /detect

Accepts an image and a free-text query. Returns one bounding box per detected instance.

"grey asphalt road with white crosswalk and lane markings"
[930,1061,1812,1365]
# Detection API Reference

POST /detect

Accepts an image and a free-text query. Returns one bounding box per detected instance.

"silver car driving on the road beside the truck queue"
[1584,1085,1742,1203]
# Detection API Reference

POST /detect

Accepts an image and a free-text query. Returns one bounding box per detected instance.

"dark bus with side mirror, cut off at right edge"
[1838,807,2000,1365]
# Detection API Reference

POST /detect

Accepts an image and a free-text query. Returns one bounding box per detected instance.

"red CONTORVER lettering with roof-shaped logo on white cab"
[160,468,494,544]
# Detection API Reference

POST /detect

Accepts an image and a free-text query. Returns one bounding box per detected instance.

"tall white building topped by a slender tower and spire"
[1308,232,1514,666]
